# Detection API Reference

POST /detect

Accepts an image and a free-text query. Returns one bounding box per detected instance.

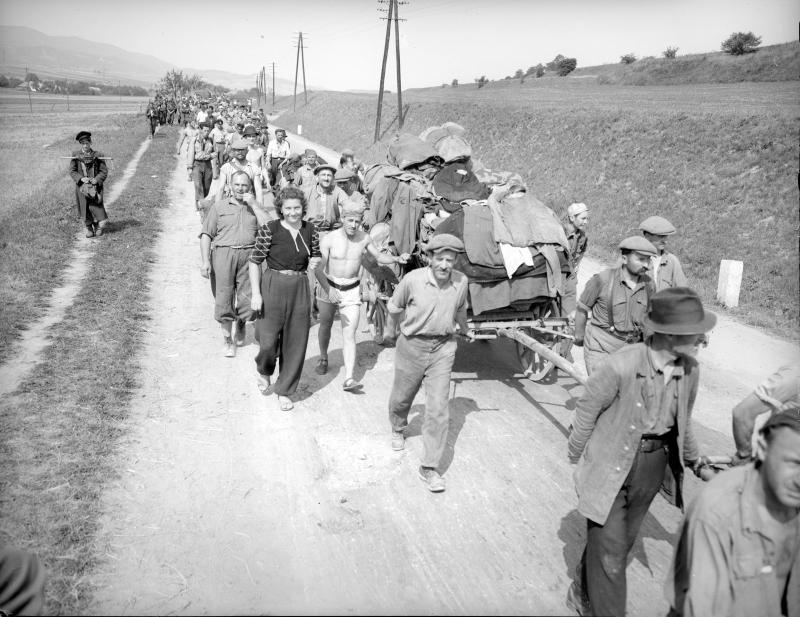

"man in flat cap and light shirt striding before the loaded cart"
[384,233,472,493]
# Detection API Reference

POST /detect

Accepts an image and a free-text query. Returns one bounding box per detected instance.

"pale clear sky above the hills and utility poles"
[0,0,800,90]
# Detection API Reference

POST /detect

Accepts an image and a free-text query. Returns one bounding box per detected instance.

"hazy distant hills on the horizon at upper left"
[0,26,294,94]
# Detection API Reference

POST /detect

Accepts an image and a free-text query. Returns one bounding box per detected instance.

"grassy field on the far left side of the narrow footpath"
[0,112,147,361]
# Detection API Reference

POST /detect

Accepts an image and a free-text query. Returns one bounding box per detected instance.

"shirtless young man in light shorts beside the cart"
[314,201,411,392]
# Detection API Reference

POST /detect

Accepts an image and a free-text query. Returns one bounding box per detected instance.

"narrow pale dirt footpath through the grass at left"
[0,139,150,396]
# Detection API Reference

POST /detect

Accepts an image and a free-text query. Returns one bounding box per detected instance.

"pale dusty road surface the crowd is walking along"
[90,142,796,616]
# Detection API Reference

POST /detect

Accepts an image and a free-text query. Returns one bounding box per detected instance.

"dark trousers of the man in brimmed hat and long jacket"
[581,447,668,617]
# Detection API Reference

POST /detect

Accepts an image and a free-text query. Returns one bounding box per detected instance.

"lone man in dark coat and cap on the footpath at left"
[69,131,108,238]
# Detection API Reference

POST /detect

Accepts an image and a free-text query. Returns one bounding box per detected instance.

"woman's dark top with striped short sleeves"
[250,219,322,272]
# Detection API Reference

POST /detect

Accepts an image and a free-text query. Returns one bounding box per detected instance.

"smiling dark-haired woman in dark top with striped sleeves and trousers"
[250,186,321,411]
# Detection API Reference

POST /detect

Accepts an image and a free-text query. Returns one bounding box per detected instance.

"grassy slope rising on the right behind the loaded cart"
[279,80,798,336]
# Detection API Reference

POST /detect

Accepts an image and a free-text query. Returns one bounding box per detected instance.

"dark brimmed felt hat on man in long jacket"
[644,287,717,334]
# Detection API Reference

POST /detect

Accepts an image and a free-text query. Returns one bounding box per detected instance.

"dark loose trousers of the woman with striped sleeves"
[256,269,311,396]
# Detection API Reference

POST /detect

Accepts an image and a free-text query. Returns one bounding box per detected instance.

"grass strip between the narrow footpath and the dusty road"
[0,124,175,614]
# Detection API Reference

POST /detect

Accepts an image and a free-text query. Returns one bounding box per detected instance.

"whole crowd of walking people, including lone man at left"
[50,94,800,617]
